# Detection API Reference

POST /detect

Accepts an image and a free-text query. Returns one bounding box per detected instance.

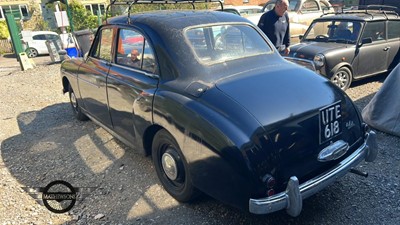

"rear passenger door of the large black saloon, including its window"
[107,28,158,146]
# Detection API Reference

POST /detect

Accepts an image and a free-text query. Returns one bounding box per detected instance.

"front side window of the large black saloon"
[92,28,113,62]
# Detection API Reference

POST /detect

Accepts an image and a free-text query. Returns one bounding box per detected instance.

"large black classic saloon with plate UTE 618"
[61,0,377,216]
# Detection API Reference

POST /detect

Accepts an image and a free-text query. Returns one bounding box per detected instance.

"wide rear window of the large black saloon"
[185,25,272,64]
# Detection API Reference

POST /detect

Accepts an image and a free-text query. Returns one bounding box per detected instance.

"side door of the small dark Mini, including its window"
[354,21,389,77]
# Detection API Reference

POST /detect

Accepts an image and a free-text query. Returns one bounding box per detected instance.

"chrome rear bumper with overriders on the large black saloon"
[249,131,378,217]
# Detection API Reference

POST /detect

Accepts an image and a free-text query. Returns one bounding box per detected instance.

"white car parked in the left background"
[21,31,61,58]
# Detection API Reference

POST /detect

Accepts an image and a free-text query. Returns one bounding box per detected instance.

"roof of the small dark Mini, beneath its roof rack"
[315,10,400,22]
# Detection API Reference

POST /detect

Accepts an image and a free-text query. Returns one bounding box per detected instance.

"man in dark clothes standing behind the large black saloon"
[258,0,290,55]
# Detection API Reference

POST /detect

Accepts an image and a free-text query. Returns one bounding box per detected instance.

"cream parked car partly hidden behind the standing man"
[247,0,333,44]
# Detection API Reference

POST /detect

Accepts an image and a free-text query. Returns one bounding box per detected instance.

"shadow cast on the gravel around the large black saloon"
[1,92,394,224]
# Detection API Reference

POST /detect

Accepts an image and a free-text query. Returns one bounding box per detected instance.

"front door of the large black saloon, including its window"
[78,26,114,128]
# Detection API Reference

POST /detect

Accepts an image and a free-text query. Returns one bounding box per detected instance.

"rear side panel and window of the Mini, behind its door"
[387,20,400,70]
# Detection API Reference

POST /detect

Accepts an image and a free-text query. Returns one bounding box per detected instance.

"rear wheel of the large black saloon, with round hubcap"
[152,129,199,202]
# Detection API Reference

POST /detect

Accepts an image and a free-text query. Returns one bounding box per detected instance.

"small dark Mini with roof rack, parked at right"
[287,6,400,90]
